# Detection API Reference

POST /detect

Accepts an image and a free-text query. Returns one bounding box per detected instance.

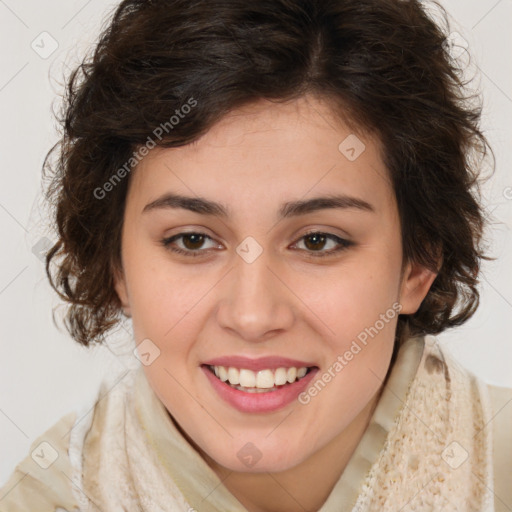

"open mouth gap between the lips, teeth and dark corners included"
[202,365,317,393]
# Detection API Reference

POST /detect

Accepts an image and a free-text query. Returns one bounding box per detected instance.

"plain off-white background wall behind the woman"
[0,0,512,485]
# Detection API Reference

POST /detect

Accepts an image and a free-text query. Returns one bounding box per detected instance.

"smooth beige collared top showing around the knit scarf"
[0,336,512,512]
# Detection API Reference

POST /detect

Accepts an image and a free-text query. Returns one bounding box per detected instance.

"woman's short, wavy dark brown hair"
[43,0,492,346]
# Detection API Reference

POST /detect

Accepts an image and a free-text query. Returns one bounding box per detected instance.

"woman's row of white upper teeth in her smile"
[210,366,308,389]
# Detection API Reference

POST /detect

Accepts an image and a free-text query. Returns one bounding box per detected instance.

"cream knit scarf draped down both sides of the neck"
[66,336,494,512]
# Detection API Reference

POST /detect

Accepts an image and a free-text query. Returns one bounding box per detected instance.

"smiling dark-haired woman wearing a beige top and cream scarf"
[2,0,512,512]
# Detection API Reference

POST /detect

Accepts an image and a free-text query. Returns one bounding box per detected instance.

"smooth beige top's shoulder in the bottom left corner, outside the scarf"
[0,412,79,512]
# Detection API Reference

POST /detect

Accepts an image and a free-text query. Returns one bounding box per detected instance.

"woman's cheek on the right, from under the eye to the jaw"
[302,261,400,424]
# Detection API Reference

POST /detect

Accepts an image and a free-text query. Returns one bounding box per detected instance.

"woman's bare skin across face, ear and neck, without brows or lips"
[116,96,436,512]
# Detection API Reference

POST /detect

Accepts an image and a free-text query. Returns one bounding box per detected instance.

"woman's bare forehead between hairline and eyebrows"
[126,97,393,220]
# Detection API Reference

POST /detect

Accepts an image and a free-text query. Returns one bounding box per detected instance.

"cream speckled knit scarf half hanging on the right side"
[353,336,494,512]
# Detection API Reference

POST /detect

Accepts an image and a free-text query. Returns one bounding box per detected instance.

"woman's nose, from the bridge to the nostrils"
[217,251,294,342]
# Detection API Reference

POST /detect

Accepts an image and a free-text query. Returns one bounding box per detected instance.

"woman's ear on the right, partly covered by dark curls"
[399,262,440,315]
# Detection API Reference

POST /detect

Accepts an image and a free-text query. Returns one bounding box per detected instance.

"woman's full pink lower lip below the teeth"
[201,366,318,413]
